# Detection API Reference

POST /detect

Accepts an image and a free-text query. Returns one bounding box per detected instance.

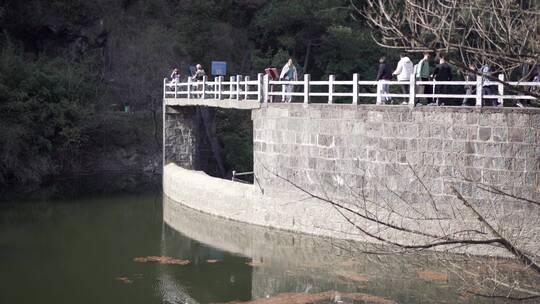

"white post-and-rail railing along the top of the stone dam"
[163,74,540,107]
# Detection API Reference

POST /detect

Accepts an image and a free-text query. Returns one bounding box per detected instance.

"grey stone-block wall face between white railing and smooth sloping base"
[252,104,540,201]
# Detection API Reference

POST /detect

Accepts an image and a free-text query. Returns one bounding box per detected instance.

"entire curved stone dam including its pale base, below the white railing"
[163,103,540,254]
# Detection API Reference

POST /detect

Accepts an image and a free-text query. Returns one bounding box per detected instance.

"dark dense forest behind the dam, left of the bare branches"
[0,0,392,188]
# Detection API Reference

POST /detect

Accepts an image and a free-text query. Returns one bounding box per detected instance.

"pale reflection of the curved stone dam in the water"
[162,197,520,303]
